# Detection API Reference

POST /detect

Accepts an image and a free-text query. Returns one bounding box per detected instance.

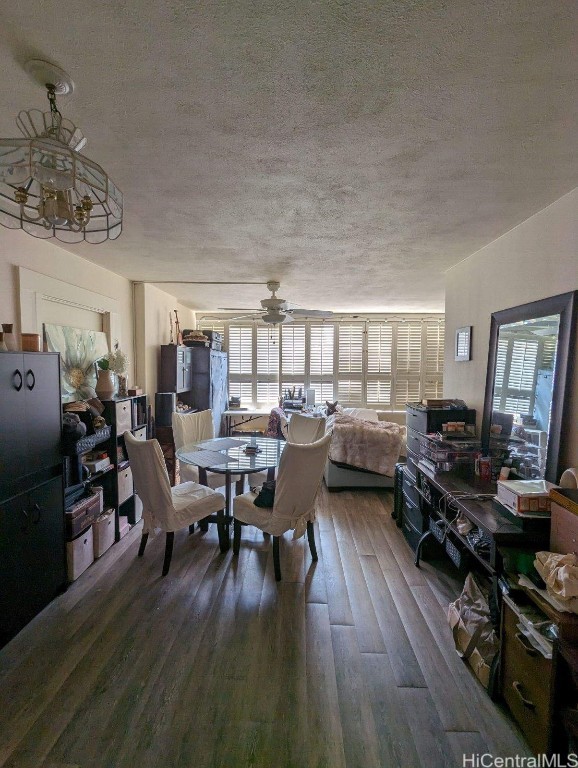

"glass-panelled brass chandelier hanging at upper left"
[0,60,122,243]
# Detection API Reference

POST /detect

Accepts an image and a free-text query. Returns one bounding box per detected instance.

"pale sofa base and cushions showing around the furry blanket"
[324,408,405,491]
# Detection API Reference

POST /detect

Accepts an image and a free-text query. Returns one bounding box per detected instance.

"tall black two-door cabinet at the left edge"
[0,352,66,644]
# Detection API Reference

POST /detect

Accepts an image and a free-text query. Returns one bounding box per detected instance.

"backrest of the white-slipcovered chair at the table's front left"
[124,432,174,532]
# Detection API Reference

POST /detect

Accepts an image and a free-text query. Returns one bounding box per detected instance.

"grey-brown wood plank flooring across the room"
[0,487,531,768]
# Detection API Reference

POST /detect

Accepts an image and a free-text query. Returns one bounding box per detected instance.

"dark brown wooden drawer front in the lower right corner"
[502,603,554,754]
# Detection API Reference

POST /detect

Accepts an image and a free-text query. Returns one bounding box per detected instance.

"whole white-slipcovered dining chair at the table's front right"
[233,434,331,581]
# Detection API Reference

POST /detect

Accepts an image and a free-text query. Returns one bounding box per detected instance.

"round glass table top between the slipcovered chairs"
[176,437,286,475]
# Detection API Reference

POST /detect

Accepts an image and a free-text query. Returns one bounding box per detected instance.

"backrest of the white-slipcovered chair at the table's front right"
[272,434,331,535]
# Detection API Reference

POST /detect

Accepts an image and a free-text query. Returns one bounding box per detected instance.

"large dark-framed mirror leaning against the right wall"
[482,291,578,483]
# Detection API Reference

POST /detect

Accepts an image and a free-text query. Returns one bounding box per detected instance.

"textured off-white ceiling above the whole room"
[0,0,578,312]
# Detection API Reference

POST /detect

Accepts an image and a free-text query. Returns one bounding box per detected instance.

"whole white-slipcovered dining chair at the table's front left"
[124,431,230,576]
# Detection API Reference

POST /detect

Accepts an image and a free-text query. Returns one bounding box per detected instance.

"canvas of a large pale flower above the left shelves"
[44,323,109,403]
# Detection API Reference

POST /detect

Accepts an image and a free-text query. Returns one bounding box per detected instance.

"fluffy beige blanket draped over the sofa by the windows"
[327,413,405,477]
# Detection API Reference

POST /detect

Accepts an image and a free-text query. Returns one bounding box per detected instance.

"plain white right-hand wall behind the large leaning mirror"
[444,188,578,474]
